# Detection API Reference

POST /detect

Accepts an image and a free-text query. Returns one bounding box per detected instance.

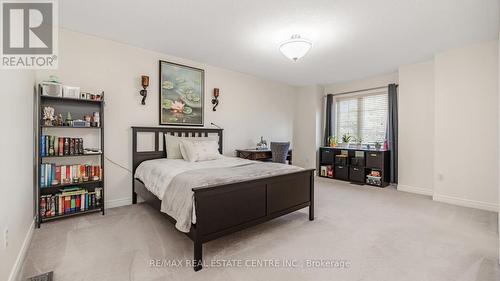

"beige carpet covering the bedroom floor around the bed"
[23,179,500,281]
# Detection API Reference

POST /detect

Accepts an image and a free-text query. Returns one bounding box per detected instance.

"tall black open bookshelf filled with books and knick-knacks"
[34,85,106,228]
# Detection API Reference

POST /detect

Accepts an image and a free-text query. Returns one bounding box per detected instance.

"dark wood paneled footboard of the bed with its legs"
[193,170,314,269]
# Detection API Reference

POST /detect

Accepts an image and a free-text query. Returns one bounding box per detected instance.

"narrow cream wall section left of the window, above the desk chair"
[293,86,325,168]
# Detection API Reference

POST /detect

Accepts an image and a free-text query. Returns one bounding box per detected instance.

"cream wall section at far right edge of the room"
[432,41,498,211]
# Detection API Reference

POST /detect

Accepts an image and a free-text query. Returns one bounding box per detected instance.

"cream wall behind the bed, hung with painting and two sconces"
[37,30,295,206]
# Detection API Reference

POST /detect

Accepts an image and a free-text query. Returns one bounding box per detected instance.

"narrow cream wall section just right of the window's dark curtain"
[398,61,434,195]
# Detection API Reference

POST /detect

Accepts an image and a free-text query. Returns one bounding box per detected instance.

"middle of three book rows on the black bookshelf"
[40,163,102,188]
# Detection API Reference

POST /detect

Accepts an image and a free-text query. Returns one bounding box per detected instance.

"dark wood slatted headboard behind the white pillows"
[132,127,223,174]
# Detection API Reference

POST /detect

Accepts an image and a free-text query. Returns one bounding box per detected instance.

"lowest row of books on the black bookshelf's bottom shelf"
[40,187,102,218]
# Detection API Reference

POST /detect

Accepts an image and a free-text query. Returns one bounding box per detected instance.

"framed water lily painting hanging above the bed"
[159,60,205,126]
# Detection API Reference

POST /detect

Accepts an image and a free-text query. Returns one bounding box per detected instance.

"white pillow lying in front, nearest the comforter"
[180,139,222,162]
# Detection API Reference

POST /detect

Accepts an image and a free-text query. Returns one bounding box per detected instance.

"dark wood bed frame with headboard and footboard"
[132,127,314,271]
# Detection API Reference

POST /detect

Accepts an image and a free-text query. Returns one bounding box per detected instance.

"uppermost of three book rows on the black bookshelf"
[40,135,84,156]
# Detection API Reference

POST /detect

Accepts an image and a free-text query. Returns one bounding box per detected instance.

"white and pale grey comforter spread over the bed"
[135,157,301,232]
